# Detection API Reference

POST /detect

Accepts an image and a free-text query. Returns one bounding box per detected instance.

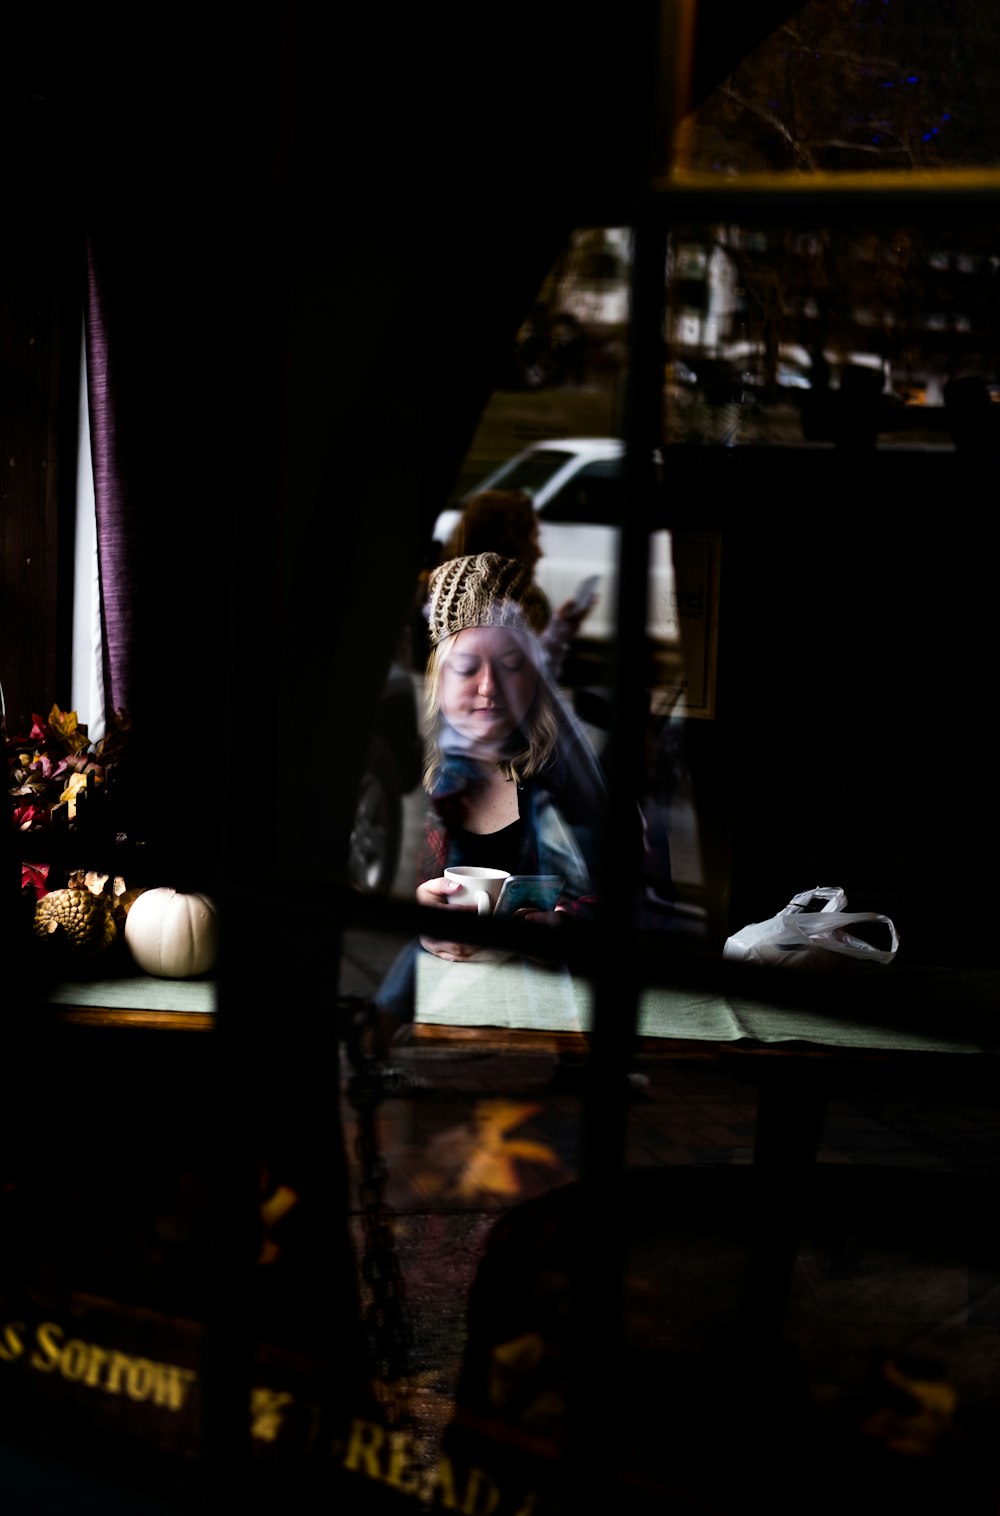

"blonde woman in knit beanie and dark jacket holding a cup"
[377,553,605,1043]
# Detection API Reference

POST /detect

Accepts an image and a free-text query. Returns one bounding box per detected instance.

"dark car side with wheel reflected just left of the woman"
[347,661,423,894]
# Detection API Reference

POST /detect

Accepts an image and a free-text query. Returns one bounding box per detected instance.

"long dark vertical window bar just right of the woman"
[567,189,667,1508]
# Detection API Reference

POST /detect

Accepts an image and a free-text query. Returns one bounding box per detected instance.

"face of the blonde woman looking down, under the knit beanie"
[438,626,538,747]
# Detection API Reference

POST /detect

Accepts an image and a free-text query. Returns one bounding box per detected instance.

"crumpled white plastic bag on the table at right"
[723,885,900,969]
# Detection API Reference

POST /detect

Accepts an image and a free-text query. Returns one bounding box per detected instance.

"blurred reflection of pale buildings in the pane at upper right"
[668,226,1000,403]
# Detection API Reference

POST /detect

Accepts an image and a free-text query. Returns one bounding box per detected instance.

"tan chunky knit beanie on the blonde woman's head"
[427,553,544,647]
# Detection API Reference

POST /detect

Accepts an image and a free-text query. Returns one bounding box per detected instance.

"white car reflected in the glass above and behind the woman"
[433,437,677,641]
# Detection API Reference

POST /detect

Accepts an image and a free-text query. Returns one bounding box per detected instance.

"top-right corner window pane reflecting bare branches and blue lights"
[666,0,1000,178]
